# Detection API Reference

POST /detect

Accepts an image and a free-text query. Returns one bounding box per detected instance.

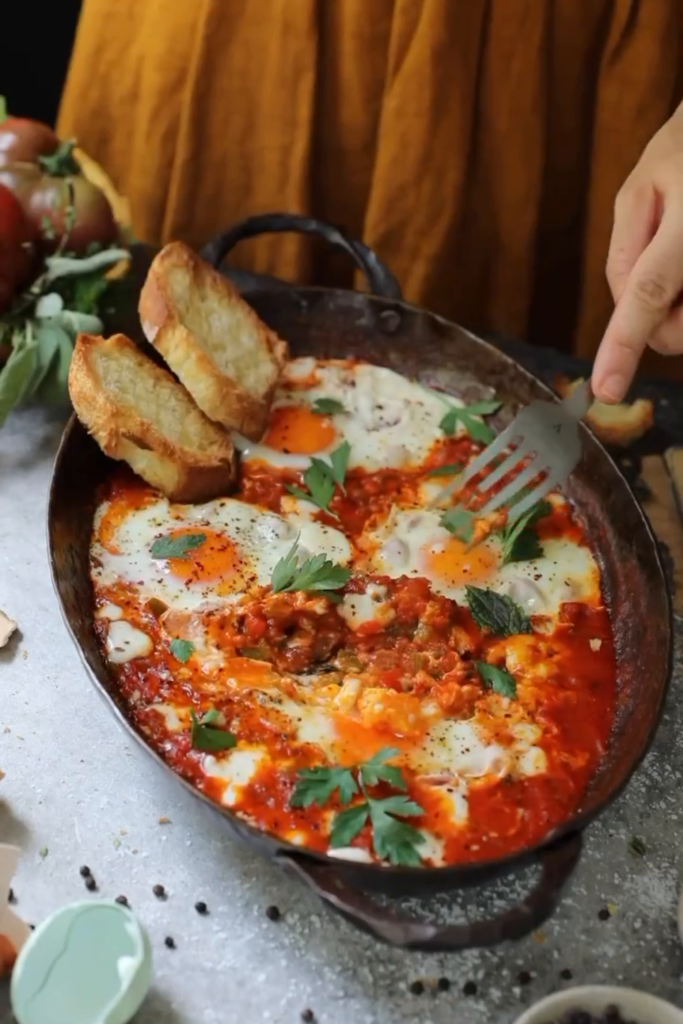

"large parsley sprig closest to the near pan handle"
[290,746,424,866]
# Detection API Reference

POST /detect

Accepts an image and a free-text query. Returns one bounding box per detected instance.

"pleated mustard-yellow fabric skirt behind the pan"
[58,0,683,368]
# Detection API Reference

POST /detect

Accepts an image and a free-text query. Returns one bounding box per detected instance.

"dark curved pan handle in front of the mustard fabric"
[197,213,402,300]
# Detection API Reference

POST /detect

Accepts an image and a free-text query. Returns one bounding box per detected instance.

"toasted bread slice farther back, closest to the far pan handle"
[138,242,289,440]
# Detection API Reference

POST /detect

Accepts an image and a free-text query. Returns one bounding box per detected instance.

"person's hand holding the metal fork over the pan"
[591,104,683,401]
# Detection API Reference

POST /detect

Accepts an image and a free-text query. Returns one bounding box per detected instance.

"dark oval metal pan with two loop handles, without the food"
[48,214,672,951]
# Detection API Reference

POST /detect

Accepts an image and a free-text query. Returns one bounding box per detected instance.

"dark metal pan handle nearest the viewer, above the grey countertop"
[278,833,582,952]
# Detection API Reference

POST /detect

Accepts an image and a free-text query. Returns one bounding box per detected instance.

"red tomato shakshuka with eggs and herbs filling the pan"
[91,356,615,866]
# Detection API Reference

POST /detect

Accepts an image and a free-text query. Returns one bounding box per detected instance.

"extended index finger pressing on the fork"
[591,207,683,401]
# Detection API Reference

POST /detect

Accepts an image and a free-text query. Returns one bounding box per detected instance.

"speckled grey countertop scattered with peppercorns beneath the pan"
[0,411,683,1024]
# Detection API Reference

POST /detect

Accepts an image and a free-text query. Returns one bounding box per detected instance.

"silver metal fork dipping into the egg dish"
[432,380,593,522]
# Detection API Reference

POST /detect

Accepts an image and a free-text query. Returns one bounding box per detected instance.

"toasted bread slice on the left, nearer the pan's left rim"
[69,334,236,502]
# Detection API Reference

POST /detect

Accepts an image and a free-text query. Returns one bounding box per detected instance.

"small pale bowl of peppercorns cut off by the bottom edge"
[515,985,683,1024]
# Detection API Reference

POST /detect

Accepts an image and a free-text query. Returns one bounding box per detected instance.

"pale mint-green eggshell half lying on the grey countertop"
[10,900,152,1024]
